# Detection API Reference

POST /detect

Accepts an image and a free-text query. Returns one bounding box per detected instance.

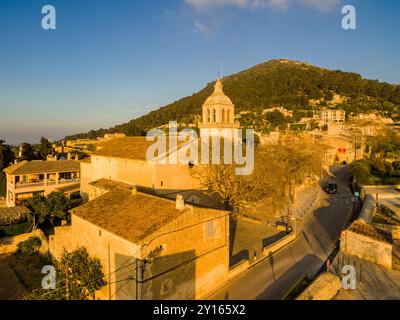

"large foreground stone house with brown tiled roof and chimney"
[50,179,229,300]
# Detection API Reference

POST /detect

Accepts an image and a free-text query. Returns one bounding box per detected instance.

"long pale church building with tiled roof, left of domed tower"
[81,137,215,206]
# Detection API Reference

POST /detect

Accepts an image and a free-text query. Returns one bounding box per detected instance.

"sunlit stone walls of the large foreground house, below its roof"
[50,211,229,300]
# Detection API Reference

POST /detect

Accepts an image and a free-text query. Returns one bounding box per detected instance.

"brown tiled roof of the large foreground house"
[72,188,228,243]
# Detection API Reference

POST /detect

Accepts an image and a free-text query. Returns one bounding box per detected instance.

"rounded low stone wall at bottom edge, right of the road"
[296,272,342,300]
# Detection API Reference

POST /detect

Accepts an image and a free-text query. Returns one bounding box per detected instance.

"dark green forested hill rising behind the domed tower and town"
[67,59,400,139]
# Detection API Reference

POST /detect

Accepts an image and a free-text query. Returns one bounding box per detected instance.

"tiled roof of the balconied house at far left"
[4,160,80,175]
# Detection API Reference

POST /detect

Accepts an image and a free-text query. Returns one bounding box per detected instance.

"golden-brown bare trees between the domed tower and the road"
[193,138,324,214]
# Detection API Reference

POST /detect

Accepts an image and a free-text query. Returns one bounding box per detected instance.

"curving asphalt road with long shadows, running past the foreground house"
[209,167,353,300]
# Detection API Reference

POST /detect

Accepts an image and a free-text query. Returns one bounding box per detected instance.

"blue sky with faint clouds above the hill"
[0,0,400,144]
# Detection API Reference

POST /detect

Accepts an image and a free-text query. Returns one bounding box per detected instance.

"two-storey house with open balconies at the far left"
[4,160,81,207]
